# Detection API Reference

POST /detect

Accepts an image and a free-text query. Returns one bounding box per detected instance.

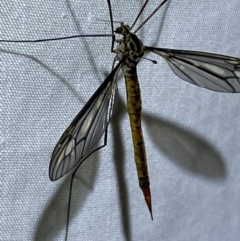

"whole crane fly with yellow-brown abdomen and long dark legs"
[1,0,240,238]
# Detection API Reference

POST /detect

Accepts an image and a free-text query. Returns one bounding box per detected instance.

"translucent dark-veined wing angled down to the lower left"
[49,61,122,181]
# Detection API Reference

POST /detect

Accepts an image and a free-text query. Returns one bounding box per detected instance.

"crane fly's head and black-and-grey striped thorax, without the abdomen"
[114,23,144,75]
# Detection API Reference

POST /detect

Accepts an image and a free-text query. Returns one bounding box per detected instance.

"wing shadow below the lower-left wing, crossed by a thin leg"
[33,153,99,241]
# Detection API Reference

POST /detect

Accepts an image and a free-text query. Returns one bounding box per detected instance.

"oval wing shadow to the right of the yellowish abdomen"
[143,112,227,179]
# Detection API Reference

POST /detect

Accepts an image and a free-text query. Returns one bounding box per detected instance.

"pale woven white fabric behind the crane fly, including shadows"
[0,0,240,241]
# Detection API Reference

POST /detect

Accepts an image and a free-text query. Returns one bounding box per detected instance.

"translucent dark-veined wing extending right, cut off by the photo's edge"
[145,47,240,93]
